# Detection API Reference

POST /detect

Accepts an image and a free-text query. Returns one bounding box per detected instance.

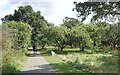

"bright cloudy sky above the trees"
[0,0,91,25]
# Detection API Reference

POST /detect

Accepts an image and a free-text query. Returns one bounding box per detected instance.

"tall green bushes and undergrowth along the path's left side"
[2,21,31,73]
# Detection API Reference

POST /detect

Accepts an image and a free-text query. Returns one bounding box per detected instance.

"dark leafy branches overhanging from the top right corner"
[73,2,120,22]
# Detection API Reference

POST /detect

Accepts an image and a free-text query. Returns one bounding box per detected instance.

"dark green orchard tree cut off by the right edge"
[106,23,120,50]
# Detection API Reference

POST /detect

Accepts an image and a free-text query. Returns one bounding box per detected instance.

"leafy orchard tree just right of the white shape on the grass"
[51,25,67,52]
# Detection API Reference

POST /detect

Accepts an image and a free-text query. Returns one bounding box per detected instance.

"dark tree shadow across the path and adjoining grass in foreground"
[20,63,86,75]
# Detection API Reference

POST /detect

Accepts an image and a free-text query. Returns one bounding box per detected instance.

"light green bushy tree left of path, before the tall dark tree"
[4,21,31,52]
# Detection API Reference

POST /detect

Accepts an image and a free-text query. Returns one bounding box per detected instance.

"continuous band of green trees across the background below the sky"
[1,3,120,52]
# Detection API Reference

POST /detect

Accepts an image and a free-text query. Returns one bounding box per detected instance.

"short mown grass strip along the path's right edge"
[40,48,83,73]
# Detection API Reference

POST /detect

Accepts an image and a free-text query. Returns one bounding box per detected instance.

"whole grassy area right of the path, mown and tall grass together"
[40,48,118,73]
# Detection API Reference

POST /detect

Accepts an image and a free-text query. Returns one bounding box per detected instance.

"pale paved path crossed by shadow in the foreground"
[21,51,58,75]
